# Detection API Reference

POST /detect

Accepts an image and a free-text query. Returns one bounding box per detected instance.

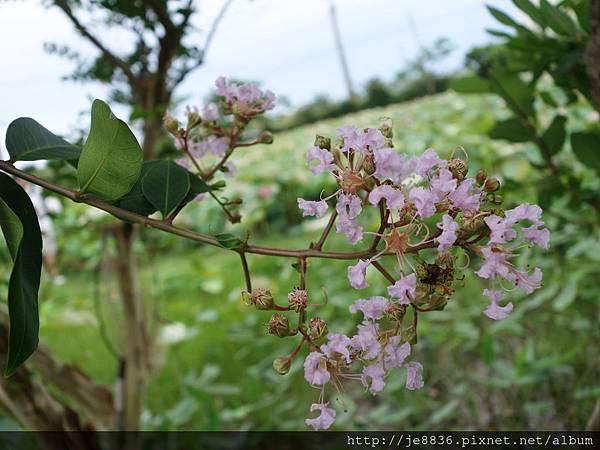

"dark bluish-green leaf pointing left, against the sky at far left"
[6,117,81,161]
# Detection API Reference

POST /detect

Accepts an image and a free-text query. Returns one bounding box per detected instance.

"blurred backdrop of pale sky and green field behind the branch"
[0,0,600,430]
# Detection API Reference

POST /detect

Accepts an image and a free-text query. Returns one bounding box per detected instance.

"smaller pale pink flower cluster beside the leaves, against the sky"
[164,77,275,222]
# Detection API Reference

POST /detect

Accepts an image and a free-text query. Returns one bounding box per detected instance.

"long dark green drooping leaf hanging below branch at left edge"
[0,173,42,376]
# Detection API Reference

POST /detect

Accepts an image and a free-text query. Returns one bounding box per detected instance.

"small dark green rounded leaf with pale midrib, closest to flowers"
[142,161,190,218]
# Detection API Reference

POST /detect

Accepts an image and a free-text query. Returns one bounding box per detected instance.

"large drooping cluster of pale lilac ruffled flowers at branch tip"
[290,121,550,429]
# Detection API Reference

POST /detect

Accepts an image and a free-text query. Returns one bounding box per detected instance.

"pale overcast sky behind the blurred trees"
[0,0,515,144]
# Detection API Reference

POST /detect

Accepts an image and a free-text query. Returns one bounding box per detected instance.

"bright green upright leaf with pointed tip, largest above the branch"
[77,100,143,200]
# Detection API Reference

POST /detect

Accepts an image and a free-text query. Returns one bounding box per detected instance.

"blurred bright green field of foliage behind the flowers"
[0,87,600,430]
